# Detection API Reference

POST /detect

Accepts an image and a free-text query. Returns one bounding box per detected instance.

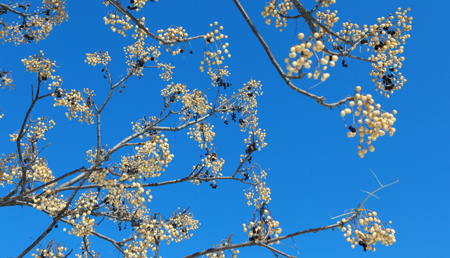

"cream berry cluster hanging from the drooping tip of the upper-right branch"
[341,86,397,158]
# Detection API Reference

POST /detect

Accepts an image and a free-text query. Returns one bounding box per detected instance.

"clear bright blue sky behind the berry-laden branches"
[0,0,450,257]
